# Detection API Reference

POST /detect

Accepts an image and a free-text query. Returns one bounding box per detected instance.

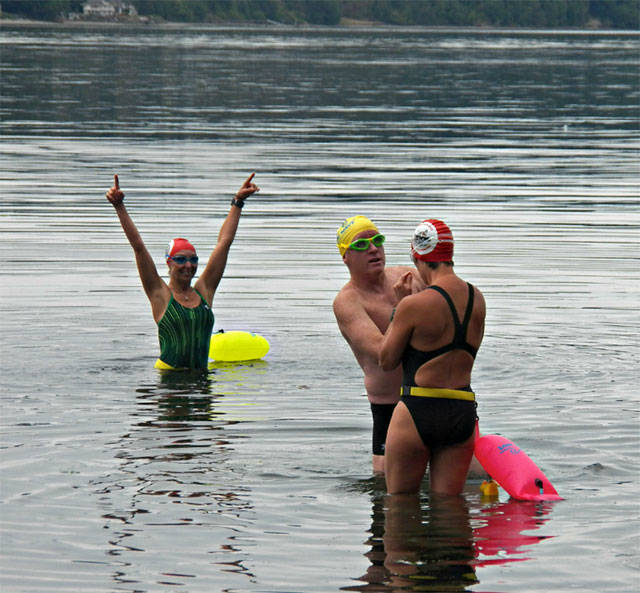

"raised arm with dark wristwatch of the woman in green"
[194,173,260,305]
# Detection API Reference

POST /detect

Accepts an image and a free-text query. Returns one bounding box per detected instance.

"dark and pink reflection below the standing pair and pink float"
[342,492,552,592]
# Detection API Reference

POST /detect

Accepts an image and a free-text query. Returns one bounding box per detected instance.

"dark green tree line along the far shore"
[1,0,640,30]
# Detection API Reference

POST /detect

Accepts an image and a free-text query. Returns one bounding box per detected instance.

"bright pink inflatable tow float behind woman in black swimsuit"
[474,434,563,501]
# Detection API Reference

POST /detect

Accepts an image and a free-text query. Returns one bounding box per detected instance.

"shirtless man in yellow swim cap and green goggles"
[333,216,425,473]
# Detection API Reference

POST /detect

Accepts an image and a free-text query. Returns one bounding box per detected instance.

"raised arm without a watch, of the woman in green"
[106,175,169,316]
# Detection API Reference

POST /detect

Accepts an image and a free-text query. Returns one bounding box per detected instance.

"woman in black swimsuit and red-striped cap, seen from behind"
[380,219,485,494]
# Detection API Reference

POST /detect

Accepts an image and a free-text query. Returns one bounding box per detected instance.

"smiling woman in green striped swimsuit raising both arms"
[107,173,260,369]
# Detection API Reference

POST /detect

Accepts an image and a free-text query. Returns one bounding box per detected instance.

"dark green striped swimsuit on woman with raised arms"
[158,291,213,369]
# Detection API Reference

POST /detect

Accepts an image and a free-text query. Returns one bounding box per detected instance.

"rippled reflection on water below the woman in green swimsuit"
[92,362,266,584]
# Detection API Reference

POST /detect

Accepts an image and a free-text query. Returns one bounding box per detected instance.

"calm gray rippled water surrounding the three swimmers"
[0,24,640,593]
